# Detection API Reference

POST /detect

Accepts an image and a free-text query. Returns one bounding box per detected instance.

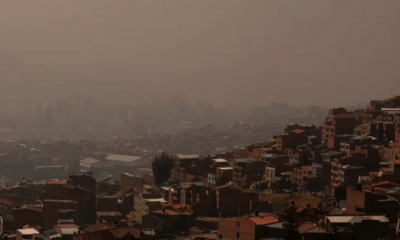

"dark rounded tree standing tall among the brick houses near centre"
[151,152,173,186]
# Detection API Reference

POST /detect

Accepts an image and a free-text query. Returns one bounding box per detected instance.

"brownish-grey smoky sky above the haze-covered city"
[0,0,400,106]
